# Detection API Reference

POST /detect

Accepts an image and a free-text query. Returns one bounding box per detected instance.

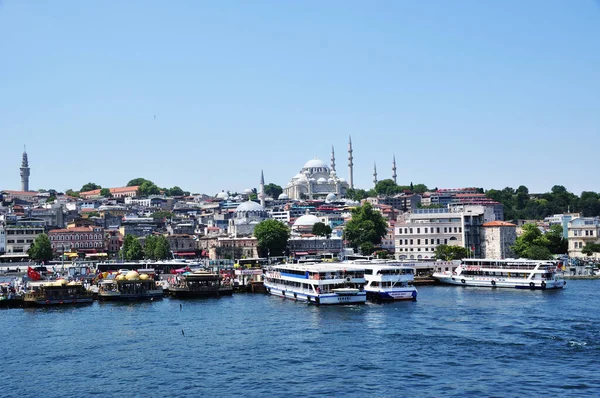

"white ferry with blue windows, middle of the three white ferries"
[342,260,417,302]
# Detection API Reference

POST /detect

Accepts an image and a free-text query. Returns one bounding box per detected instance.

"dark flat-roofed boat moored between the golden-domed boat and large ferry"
[169,270,233,298]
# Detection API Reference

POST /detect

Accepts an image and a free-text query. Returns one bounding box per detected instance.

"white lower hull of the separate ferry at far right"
[433,274,566,290]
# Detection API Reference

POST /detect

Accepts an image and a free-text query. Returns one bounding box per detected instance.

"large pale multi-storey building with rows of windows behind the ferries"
[394,208,484,259]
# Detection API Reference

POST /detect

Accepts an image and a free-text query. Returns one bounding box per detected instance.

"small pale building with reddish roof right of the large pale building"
[481,221,517,259]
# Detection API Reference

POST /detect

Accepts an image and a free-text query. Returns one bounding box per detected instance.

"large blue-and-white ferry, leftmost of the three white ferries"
[264,264,367,305]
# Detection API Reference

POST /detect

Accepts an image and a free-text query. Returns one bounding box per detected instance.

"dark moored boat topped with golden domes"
[98,271,164,301]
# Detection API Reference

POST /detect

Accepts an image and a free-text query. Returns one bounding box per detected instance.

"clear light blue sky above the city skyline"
[0,0,600,195]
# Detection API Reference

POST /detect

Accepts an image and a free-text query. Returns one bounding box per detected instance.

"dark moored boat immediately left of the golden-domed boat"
[23,279,94,307]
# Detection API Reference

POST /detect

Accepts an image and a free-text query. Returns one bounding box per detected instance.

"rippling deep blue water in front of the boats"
[0,281,600,397]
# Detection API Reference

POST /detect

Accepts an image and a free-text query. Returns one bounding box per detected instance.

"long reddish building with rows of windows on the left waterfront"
[48,226,105,253]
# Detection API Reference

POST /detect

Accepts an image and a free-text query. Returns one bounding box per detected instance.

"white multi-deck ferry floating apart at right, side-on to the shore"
[433,258,566,290]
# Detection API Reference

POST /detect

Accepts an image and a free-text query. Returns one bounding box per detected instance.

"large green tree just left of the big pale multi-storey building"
[344,203,388,250]
